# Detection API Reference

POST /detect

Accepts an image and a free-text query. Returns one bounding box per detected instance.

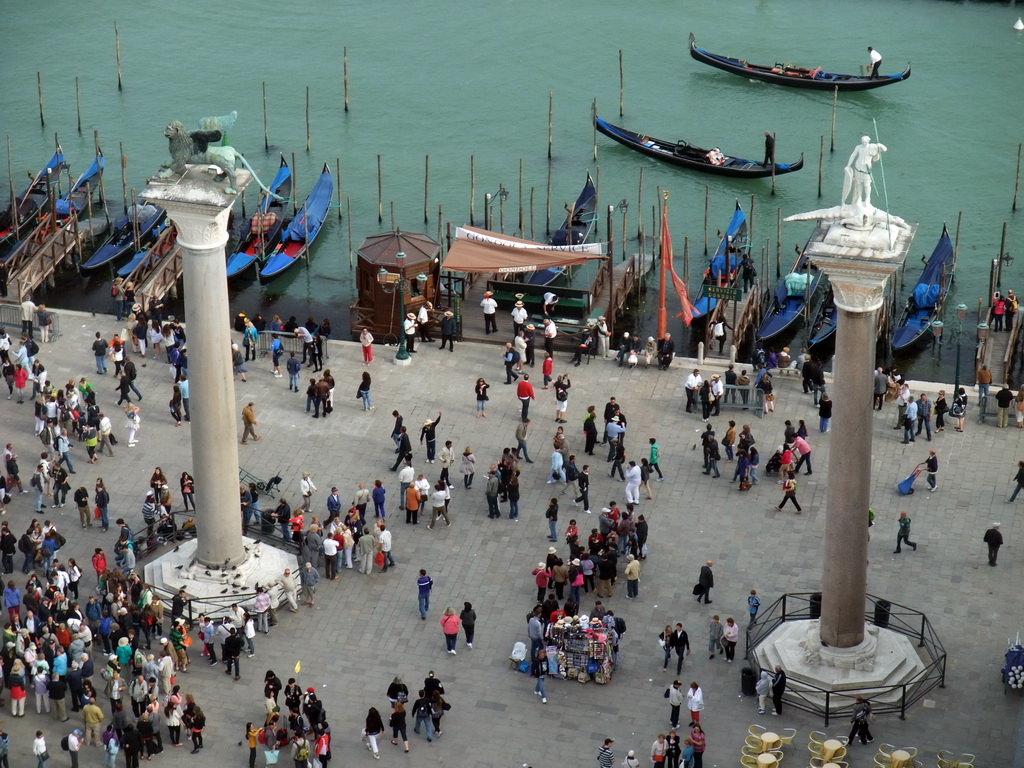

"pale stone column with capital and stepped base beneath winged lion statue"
[140,166,295,613]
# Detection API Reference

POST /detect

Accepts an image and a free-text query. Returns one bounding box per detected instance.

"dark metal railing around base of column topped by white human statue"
[743,592,946,727]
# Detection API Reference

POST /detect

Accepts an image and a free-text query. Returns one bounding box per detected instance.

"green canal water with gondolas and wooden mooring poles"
[0,0,1024,378]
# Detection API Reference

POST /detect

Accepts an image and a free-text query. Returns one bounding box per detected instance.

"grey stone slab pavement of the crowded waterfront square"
[0,312,1024,768]
